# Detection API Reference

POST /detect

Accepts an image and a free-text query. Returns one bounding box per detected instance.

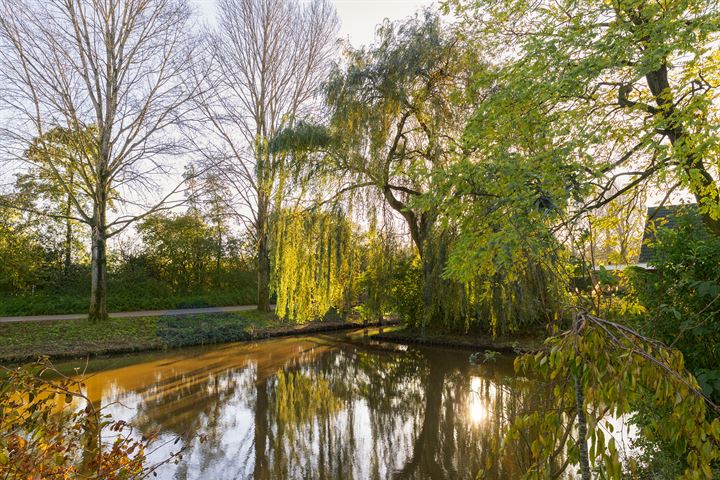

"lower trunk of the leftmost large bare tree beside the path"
[89,194,108,322]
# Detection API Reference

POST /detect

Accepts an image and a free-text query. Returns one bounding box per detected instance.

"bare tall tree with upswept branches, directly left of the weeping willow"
[190,0,338,311]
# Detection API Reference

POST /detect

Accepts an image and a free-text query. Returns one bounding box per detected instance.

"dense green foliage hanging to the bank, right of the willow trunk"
[414,49,572,334]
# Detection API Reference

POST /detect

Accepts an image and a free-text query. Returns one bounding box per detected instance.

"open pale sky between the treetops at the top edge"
[191,0,436,47]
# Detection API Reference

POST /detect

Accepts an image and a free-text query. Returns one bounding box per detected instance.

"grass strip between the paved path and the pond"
[0,311,372,363]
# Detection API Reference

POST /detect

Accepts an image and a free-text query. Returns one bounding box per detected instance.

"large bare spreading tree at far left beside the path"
[0,0,197,320]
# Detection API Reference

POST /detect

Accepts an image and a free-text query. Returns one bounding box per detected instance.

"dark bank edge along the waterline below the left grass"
[0,317,399,367]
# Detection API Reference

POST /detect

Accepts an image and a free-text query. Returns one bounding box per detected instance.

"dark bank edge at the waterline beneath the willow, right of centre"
[370,329,545,354]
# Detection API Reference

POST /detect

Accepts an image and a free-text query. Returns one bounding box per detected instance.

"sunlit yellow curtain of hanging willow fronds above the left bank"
[272,208,360,323]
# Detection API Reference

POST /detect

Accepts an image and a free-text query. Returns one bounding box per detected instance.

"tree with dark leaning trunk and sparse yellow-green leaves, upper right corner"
[448,0,720,234]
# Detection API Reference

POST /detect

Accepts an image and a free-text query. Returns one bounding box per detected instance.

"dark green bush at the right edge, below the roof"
[631,209,720,401]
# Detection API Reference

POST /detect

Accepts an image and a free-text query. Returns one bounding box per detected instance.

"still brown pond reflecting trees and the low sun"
[53,331,608,479]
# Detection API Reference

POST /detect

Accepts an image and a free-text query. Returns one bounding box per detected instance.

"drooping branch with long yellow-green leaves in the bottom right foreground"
[500,312,720,480]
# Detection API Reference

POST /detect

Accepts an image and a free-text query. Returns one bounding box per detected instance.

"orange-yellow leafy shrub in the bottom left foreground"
[0,359,203,480]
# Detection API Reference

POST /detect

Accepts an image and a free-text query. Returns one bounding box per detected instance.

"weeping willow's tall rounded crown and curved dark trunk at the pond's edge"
[274,10,490,334]
